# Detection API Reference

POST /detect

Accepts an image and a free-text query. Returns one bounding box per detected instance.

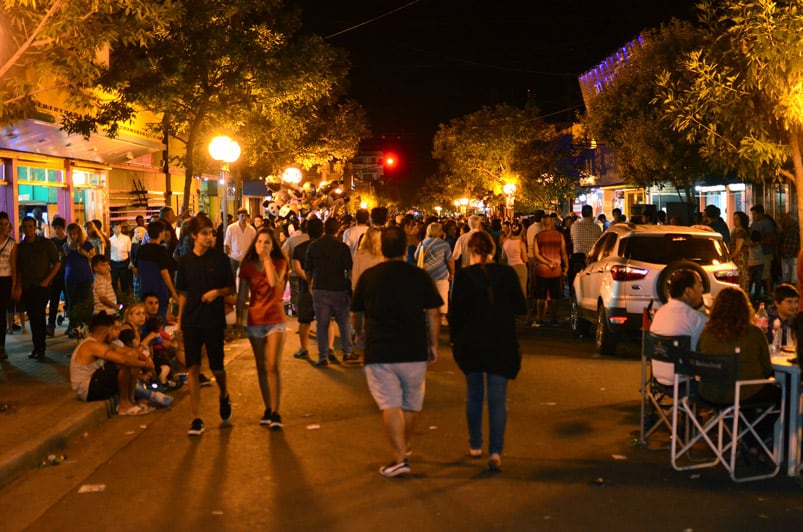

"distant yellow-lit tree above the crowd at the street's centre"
[427,104,551,211]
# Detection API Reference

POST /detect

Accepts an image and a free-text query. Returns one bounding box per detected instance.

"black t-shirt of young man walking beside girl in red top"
[176,248,234,329]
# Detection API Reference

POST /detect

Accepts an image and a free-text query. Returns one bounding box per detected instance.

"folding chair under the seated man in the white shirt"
[640,331,691,449]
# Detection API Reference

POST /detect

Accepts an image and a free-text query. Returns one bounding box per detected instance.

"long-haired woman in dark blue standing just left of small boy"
[63,222,95,335]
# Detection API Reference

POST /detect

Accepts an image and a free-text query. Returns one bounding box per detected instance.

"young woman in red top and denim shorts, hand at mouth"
[240,228,287,430]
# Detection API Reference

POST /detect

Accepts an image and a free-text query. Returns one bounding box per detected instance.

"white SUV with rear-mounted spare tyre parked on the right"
[571,223,739,354]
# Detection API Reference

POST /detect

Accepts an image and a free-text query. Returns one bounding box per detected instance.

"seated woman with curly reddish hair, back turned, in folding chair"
[697,287,781,455]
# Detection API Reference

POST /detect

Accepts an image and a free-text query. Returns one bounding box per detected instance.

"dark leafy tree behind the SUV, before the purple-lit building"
[585,20,710,201]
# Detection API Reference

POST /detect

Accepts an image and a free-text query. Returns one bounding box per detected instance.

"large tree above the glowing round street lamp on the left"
[65,0,364,214]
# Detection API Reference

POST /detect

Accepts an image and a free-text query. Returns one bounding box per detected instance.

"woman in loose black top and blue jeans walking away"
[449,231,527,471]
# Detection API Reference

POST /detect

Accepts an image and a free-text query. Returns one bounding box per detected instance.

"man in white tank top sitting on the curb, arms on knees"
[70,312,153,416]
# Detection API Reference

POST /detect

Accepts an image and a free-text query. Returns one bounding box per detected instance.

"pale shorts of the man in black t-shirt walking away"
[364,362,427,412]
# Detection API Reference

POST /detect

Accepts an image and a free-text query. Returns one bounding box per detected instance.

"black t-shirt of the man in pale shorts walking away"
[351,260,443,364]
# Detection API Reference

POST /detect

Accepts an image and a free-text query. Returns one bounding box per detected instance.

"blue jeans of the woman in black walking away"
[466,373,507,454]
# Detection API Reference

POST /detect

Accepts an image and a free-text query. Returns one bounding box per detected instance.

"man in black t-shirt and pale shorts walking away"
[351,227,443,477]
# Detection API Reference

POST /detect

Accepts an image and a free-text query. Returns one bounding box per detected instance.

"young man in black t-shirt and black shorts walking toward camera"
[176,215,235,436]
